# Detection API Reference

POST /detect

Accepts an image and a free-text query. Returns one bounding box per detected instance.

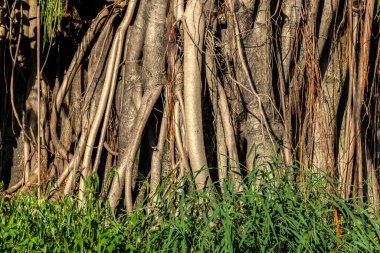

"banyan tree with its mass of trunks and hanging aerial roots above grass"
[0,0,380,211]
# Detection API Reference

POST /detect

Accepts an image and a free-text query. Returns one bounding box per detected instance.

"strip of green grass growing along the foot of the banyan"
[0,158,380,252]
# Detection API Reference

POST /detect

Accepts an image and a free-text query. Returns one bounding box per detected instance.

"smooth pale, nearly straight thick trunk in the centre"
[183,0,210,189]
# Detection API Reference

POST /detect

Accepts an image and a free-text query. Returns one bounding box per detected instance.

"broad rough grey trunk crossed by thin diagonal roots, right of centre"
[235,1,283,170]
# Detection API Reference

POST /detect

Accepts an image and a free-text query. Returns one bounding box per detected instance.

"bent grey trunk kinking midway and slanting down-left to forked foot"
[108,0,167,212]
